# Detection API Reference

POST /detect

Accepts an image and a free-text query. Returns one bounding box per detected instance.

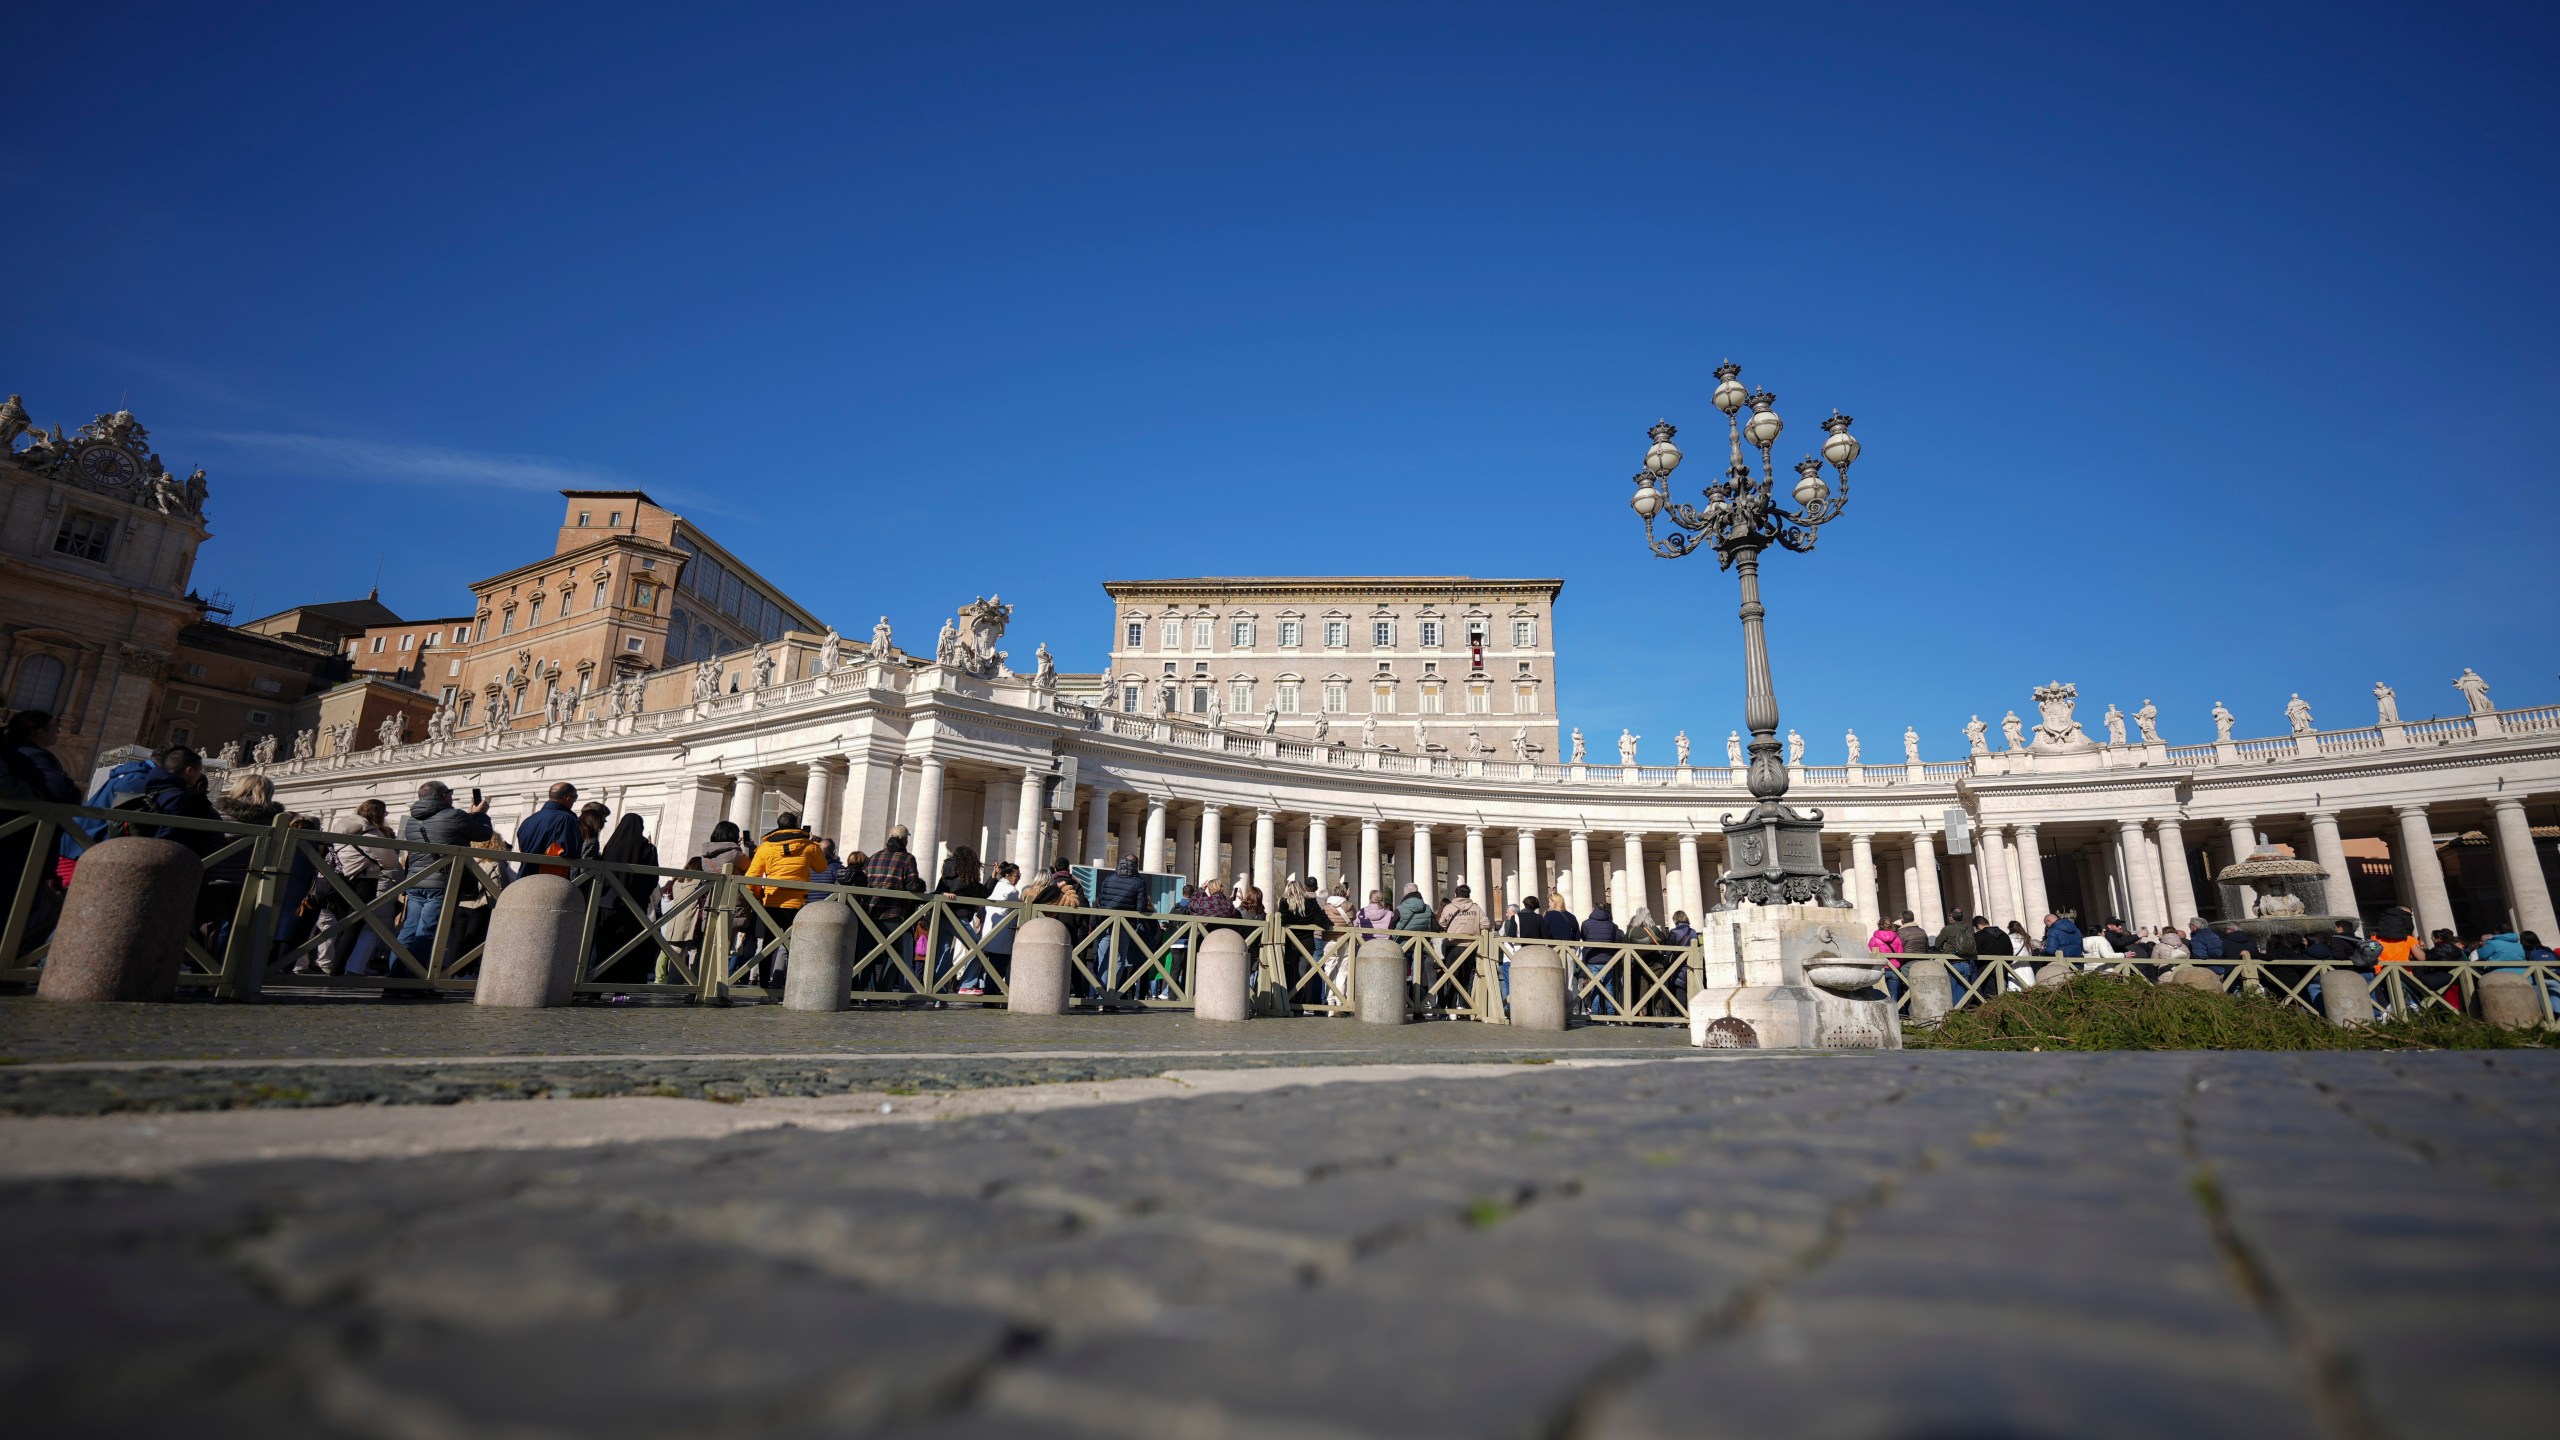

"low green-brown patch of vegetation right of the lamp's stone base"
[1902,974,2555,1051]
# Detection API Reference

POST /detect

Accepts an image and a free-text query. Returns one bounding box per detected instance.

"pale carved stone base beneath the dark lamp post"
[1690,904,1902,1051]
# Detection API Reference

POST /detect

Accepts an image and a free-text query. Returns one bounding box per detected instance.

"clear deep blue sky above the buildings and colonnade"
[0,3,2560,761]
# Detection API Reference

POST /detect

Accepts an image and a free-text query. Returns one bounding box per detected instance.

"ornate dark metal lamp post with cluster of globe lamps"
[1633,361,1859,907]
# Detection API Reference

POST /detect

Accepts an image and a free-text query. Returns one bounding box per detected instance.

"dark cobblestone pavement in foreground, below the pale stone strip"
[0,1053,2560,1440]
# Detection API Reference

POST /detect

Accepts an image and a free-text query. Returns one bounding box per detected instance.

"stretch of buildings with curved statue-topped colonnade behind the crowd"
[0,397,2560,938]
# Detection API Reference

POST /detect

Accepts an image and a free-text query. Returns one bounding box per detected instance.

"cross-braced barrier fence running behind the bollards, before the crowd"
[0,799,2560,1025]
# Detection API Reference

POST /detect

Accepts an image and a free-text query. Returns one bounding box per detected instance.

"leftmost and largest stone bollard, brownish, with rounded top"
[36,835,202,1002]
